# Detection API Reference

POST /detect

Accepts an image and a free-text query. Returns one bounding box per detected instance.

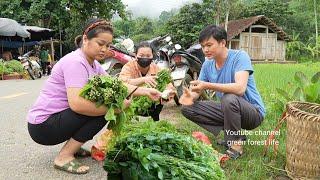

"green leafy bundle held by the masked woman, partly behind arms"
[131,69,172,115]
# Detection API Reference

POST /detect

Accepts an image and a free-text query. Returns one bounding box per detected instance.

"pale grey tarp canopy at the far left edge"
[0,18,30,38]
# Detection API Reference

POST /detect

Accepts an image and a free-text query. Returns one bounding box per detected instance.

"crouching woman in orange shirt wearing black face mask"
[119,42,175,121]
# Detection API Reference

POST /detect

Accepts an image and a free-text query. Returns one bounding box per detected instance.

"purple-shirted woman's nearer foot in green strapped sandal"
[54,155,90,174]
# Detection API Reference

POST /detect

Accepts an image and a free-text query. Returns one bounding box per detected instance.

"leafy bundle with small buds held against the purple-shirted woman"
[80,76,128,133]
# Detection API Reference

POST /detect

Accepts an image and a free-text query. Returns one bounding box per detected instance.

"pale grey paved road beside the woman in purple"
[0,78,107,180]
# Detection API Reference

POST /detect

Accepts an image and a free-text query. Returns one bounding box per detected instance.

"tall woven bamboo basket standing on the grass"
[286,101,320,179]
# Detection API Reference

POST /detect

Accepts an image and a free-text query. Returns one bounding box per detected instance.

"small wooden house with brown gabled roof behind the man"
[222,15,289,61]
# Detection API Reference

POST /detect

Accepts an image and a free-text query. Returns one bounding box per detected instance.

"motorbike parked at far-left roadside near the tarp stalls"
[18,51,42,80]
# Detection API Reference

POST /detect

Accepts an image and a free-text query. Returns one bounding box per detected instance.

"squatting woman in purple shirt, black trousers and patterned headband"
[27,19,160,174]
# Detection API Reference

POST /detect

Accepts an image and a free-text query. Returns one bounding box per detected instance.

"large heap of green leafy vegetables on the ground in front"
[104,121,225,180]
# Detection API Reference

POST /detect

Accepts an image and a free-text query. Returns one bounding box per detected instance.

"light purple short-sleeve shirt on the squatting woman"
[27,49,106,124]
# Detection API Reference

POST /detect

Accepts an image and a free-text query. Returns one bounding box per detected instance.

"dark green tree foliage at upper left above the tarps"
[0,0,126,51]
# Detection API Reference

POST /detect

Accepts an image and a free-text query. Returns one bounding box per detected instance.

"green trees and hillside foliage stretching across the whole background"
[0,0,320,59]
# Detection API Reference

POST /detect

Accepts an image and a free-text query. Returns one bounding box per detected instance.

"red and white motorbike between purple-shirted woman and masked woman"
[102,42,135,76]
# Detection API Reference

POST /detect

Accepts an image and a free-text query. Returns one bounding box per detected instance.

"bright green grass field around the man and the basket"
[169,63,320,180]
